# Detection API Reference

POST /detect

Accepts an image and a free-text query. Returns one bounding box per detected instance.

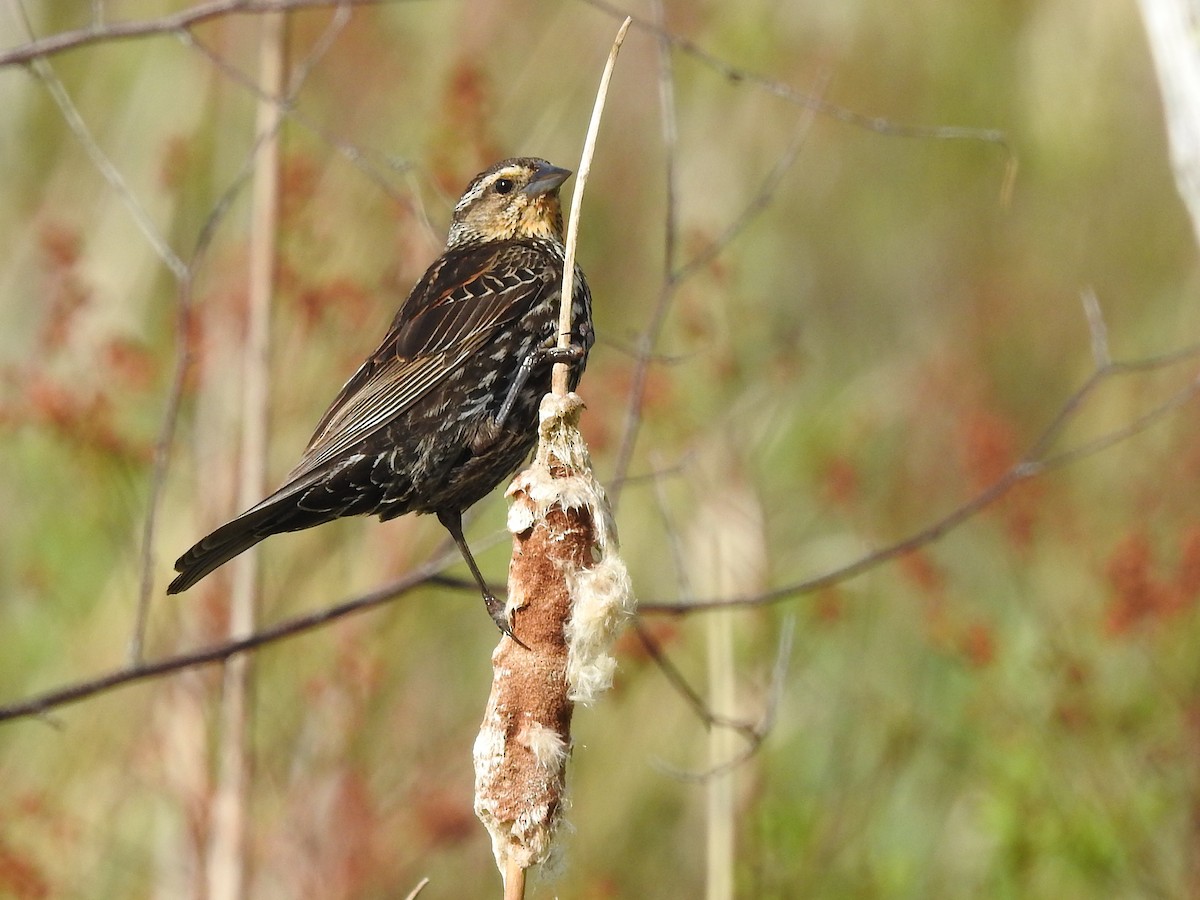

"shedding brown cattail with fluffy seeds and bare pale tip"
[474,19,632,900]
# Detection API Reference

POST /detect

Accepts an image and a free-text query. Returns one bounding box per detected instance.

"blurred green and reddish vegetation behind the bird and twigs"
[0,0,1200,899]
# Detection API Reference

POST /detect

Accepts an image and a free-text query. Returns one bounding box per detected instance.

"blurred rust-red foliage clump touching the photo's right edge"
[1105,526,1200,635]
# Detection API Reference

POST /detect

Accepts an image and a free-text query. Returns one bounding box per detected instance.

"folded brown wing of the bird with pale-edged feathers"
[287,241,553,482]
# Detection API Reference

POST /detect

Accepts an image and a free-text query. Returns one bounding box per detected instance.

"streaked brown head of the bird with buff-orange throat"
[446,157,571,247]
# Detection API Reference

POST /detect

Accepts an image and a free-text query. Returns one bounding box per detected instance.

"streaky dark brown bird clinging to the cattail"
[167,158,593,634]
